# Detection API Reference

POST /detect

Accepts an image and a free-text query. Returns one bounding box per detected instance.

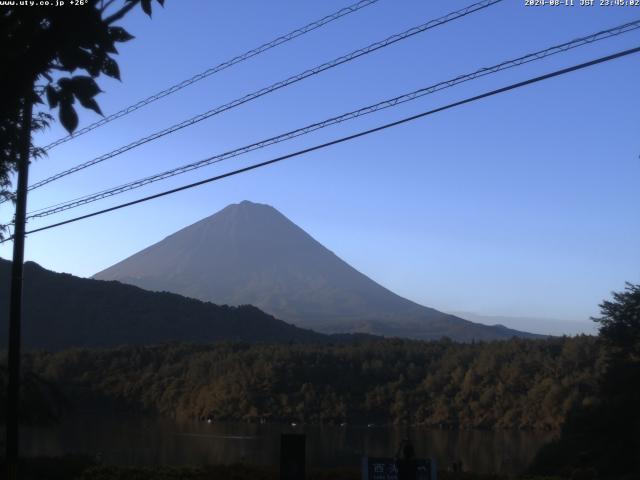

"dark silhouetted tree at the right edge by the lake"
[533,283,640,479]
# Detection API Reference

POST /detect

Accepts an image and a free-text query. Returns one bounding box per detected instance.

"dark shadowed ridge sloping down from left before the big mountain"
[0,259,345,350]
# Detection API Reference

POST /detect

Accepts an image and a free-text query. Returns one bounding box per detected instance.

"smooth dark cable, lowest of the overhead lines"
[7,47,640,243]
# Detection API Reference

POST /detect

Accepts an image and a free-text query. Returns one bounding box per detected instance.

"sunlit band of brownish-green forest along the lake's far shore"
[24,337,602,429]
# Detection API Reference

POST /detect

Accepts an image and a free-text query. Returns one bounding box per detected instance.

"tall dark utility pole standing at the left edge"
[7,94,33,480]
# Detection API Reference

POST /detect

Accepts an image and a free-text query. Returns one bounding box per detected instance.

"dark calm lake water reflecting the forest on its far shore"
[21,415,552,474]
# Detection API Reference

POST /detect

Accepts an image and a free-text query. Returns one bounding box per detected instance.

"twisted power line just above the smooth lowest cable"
[27,20,640,219]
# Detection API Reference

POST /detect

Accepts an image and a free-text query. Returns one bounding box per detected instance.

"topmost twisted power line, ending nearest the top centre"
[44,0,378,150]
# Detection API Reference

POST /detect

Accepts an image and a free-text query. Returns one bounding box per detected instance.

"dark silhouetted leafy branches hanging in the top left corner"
[0,0,164,235]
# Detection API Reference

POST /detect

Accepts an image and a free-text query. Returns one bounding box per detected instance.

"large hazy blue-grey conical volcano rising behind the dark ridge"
[94,201,533,341]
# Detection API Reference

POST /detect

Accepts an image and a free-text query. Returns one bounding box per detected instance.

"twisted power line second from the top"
[29,0,503,195]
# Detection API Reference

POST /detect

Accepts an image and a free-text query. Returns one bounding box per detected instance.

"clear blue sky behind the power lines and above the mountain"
[0,0,640,330]
